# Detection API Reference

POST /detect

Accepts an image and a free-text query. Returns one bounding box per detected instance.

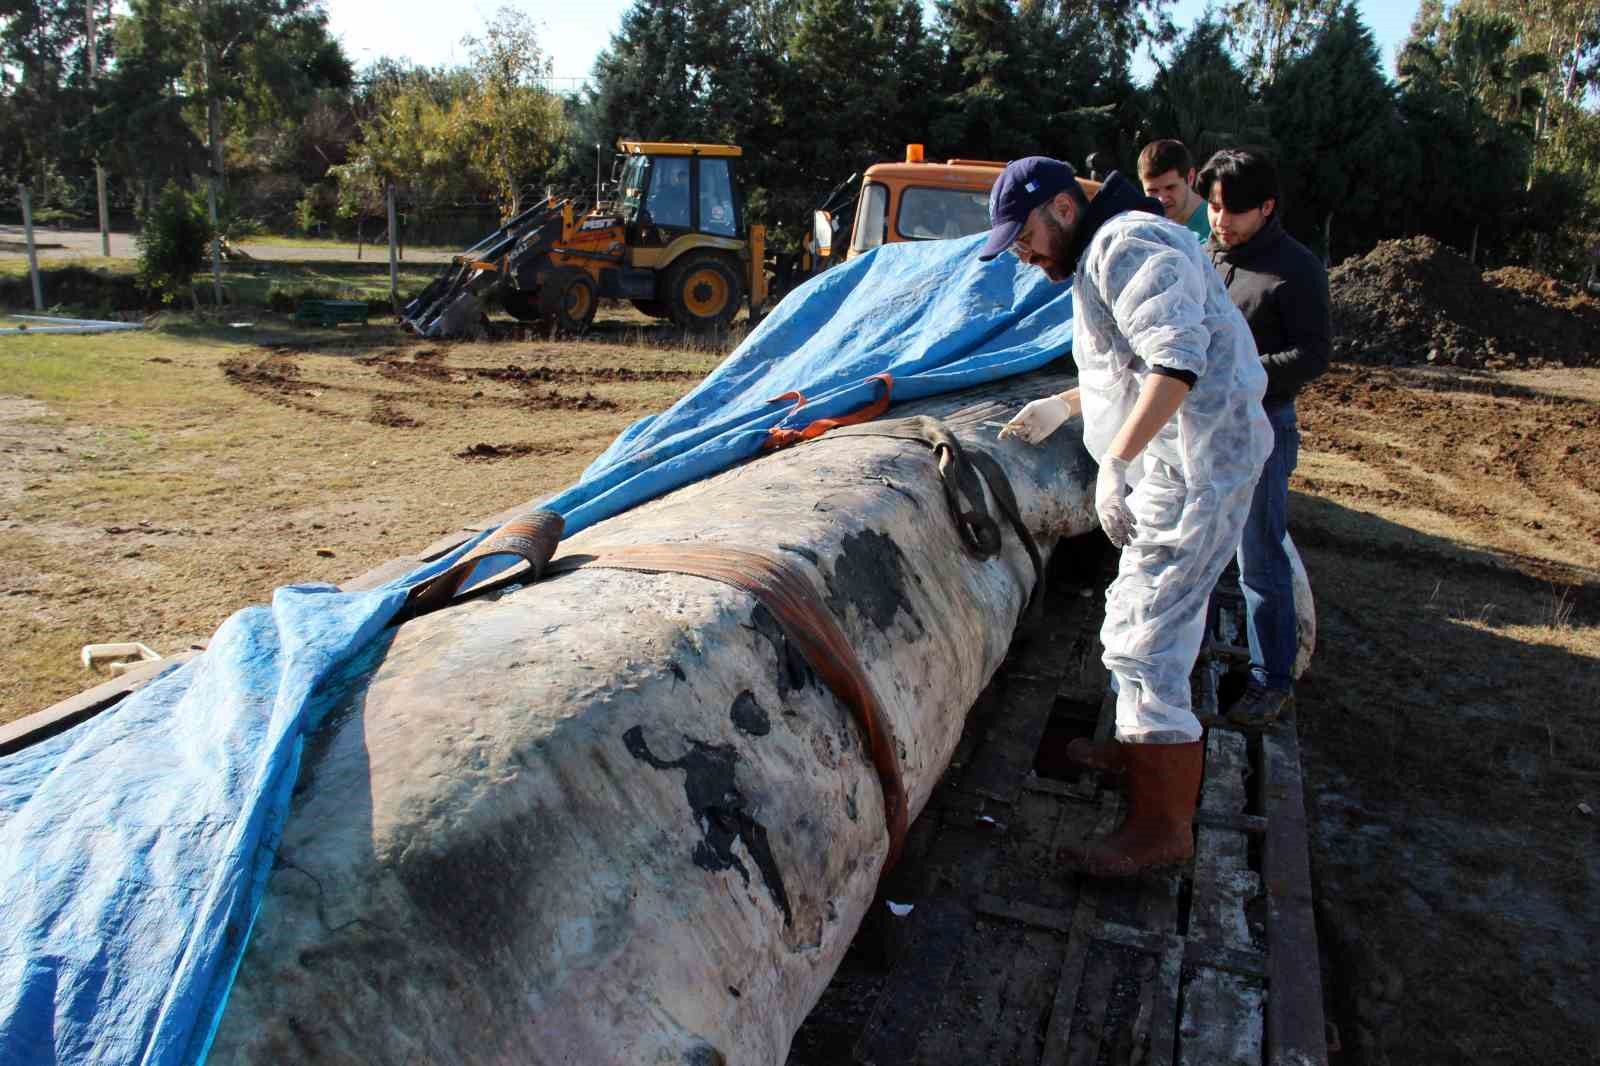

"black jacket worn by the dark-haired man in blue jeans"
[1206,214,1333,405]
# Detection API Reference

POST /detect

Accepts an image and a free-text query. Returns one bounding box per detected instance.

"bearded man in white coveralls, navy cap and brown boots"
[979,155,1272,877]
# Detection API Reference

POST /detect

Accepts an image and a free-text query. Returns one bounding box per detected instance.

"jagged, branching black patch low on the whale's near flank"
[622,725,794,927]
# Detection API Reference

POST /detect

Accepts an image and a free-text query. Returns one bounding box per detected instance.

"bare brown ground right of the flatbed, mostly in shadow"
[1291,367,1600,1064]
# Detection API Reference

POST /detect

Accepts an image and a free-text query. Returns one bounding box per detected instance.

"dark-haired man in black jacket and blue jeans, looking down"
[1200,149,1333,727]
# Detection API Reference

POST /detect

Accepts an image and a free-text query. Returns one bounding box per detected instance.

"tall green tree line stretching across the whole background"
[0,0,1600,274]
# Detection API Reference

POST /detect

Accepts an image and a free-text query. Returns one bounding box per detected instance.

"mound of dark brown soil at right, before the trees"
[1328,237,1600,370]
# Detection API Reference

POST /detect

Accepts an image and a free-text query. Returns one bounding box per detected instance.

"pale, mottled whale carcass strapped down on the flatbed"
[211,373,1299,1066]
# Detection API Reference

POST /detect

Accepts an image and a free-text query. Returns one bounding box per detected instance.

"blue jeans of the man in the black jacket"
[1238,399,1299,690]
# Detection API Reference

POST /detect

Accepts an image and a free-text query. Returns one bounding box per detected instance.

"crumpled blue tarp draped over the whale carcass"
[0,238,1072,1066]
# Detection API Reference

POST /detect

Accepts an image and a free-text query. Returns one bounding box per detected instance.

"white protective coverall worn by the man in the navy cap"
[1072,211,1272,743]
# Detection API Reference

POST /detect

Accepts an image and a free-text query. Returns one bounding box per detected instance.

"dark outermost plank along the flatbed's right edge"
[1261,722,1328,1066]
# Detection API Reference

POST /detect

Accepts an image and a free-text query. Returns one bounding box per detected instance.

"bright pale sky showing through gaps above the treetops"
[325,0,1418,91]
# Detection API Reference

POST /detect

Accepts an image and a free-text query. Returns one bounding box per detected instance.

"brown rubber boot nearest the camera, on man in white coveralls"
[1061,741,1205,877]
